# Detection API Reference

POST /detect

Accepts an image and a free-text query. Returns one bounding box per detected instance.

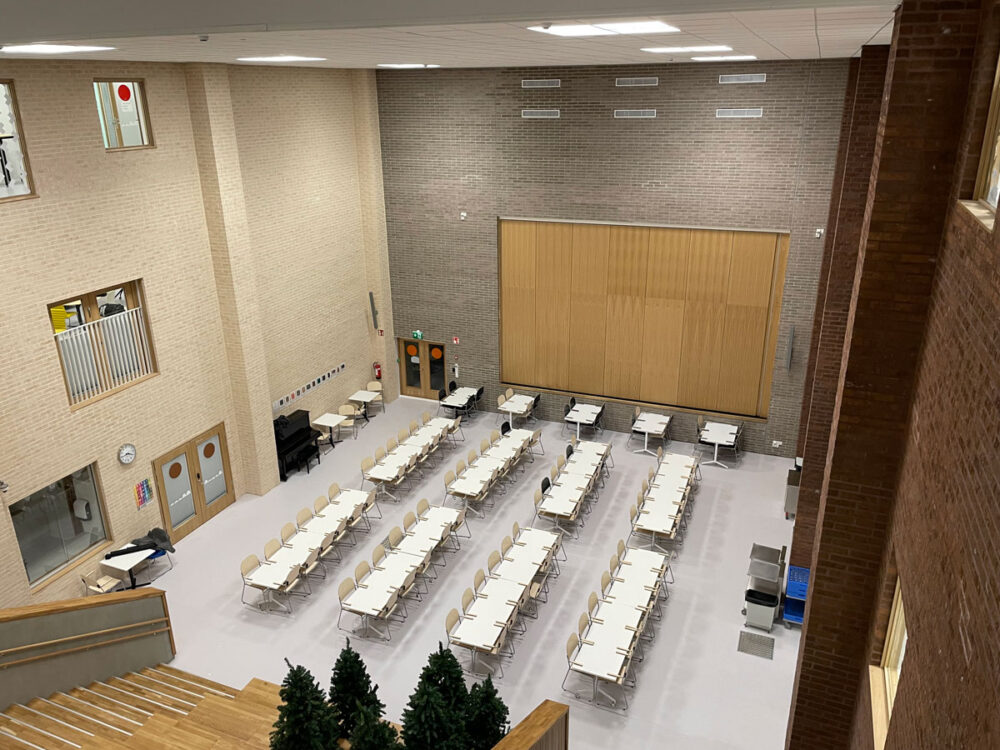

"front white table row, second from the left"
[338,506,460,640]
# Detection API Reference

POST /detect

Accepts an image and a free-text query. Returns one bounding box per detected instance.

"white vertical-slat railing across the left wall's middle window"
[55,307,154,406]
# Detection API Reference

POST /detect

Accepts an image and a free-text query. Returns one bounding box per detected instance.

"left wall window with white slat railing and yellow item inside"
[49,281,156,406]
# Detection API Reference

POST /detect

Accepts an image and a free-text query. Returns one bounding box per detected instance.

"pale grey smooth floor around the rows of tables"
[156,397,799,750]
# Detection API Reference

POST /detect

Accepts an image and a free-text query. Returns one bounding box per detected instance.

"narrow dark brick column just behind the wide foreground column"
[789,46,889,567]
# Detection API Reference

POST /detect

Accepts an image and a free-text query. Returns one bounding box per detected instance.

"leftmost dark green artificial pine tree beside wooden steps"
[271,659,339,750]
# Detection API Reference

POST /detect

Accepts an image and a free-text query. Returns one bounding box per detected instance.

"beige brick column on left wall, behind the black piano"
[185,64,278,495]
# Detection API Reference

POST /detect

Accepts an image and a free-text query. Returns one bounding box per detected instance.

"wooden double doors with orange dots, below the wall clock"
[153,424,235,542]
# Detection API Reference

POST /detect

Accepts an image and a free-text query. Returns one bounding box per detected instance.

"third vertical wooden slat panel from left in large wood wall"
[568,224,611,393]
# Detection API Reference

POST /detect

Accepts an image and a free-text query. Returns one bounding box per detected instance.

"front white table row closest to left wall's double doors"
[243,489,375,611]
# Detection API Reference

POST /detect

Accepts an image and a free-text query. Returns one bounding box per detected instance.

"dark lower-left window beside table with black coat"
[10,464,108,583]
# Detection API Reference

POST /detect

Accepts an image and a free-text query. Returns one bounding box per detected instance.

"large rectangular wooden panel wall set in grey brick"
[499,220,788,416]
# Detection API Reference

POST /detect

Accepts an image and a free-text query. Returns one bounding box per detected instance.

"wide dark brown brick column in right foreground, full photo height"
[786,0,979,750]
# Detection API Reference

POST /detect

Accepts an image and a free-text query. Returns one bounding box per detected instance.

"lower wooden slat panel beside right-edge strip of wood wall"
[716,305,767,414]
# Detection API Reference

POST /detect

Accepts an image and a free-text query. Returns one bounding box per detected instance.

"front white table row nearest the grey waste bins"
[563,548,670,708]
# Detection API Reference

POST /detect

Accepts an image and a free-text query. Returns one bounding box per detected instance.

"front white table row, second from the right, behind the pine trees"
[448,528,565,676]
